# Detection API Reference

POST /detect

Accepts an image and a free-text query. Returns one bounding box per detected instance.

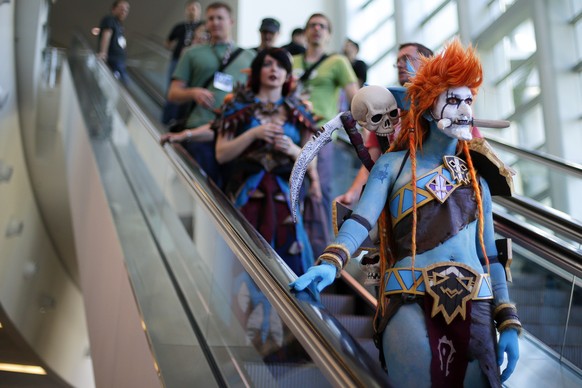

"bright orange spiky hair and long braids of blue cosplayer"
[378,39,489,318]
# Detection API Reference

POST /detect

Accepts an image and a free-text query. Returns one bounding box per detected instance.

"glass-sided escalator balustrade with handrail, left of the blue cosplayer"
[63,34,390,387]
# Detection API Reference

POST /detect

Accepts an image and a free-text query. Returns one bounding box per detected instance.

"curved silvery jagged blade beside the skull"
[289,112,343,222]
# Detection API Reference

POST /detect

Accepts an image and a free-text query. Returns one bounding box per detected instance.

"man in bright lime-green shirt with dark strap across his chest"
[293,13,358,255]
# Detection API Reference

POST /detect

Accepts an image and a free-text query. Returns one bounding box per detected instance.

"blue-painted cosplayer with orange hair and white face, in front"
[291,40,521,387]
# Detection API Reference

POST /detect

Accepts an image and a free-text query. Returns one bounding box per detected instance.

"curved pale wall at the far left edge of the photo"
[0,0,94,387]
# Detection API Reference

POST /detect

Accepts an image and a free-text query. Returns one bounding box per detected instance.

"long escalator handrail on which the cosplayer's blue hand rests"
[73,34,389,387]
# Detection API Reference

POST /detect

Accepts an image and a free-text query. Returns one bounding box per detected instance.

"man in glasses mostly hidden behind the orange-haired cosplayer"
[336,43,433,207]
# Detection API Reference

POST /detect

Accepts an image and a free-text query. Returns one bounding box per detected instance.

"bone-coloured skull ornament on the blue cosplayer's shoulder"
[351,85,398,136]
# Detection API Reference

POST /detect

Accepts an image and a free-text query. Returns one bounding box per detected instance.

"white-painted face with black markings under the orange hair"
[431,86,473,141]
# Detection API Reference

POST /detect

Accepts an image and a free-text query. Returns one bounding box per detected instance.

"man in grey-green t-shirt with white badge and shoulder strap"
[168,2,256,183]
